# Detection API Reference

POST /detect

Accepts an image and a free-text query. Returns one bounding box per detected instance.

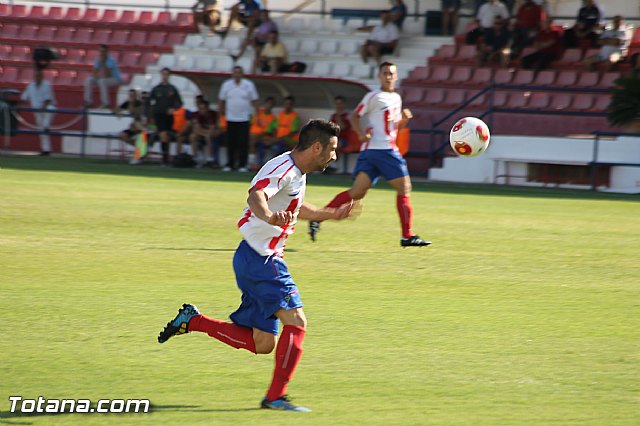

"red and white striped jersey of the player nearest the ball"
[356,89,402,151]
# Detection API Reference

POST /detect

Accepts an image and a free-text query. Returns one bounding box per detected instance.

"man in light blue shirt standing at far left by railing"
[22,69,56,155]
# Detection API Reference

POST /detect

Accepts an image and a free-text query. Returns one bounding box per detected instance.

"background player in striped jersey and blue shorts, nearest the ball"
[309,62,431,247]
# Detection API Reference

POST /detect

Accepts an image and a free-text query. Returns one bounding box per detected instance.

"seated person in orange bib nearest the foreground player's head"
[257,96,300,166]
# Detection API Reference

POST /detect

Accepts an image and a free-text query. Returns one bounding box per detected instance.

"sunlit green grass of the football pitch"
[0,157,640,425]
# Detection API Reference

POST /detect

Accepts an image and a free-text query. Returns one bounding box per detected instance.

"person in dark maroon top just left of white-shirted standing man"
[189,100,220,167]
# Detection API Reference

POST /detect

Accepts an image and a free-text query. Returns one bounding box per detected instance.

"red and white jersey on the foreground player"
[238,152,307,257]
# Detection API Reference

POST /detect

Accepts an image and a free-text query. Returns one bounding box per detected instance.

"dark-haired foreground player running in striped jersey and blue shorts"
[158,120,352,411]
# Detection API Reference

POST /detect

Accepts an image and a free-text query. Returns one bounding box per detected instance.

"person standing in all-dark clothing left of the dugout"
[149,68,182,166]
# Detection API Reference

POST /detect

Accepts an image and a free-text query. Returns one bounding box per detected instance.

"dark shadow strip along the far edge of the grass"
[0,155,640,201]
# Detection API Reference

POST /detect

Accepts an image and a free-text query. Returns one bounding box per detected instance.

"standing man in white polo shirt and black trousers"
[218,65,259,172]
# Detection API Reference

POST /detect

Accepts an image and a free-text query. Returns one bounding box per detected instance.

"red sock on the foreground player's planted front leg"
[267,325,305,401]
